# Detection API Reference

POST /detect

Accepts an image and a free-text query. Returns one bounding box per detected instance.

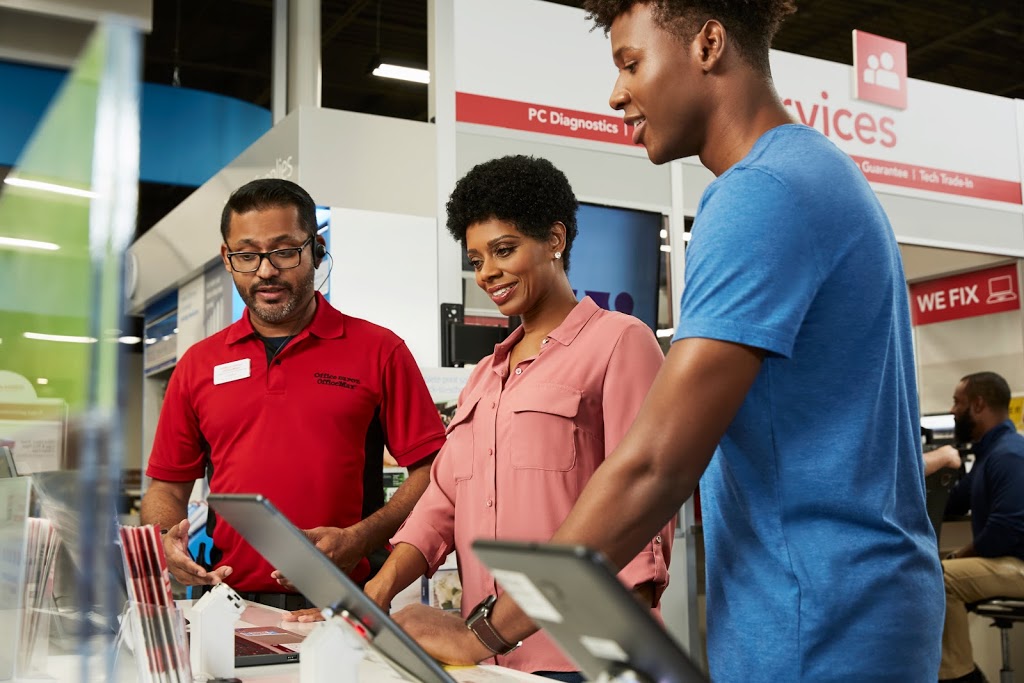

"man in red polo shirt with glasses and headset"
[141,178,444,609]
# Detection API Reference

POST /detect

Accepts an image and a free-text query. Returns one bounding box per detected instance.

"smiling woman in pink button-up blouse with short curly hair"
[380,156,673,681]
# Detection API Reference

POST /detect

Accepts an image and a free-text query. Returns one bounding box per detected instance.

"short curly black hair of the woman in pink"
[446,155,580,272]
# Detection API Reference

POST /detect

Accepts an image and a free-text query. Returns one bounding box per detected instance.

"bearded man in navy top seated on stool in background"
[939,373,1024,683]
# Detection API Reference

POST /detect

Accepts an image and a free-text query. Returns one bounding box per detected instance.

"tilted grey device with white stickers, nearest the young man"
[473,540,708,683]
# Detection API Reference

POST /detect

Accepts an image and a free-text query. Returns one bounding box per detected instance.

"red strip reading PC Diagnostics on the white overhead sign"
[455,92,633,144]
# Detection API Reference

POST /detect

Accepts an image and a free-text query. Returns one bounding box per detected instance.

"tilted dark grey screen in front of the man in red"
[207,494,455,683]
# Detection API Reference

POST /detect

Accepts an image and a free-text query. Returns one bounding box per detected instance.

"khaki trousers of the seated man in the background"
[939,557,1024,679]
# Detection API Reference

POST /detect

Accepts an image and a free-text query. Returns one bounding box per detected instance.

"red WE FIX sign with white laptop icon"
[910,263,1021,325]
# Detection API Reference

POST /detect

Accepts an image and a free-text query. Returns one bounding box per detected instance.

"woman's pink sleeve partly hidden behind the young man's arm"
[603,321,675,605]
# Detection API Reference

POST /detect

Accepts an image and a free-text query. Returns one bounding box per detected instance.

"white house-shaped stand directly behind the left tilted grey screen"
[299,607,368,683]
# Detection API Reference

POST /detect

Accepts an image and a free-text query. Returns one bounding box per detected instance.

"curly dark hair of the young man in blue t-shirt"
[583,0,797,74]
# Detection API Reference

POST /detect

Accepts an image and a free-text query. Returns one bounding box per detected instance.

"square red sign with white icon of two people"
[853,31,906,110]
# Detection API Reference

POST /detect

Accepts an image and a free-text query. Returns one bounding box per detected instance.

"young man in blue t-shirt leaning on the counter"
[389,0,944,683]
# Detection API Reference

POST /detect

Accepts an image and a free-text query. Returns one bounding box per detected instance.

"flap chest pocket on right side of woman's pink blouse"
[510,384,583,472]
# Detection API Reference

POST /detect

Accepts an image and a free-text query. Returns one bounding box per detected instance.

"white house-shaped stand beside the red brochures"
[189,584,246,678]
